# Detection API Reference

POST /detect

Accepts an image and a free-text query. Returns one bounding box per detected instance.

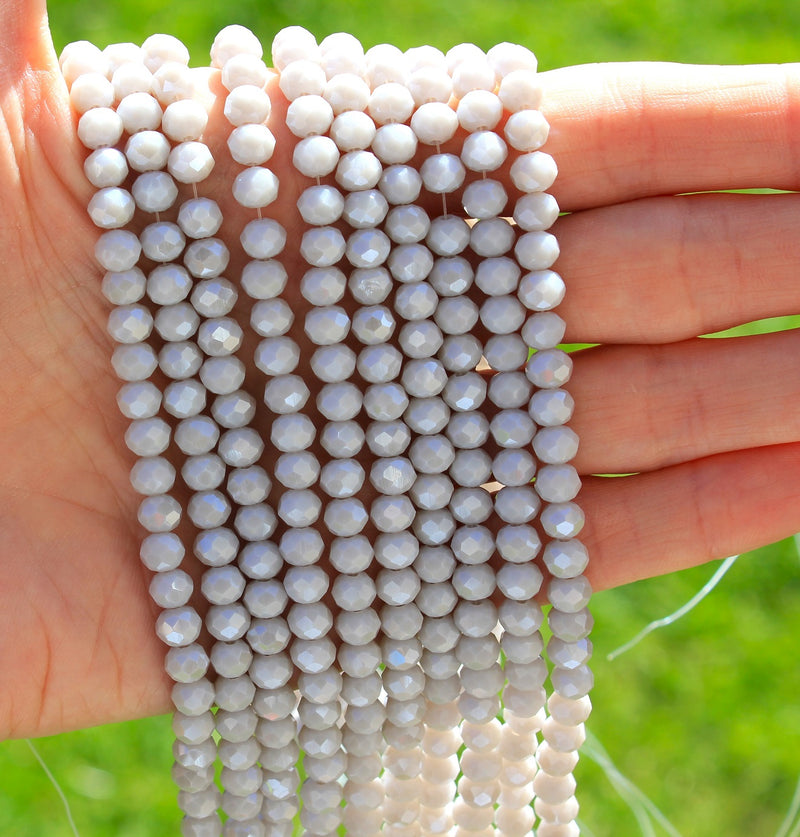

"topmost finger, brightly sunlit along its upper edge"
[542,63,800,211]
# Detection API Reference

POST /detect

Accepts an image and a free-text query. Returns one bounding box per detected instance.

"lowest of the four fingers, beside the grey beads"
[580,444,800,590]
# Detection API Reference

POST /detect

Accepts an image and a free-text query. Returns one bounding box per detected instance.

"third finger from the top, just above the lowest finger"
[569,331,800,474]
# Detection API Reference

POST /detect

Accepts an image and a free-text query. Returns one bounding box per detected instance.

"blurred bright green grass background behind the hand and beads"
[0,0,800,837]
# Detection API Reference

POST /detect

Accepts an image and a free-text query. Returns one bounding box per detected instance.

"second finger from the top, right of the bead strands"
[554,195,800,343]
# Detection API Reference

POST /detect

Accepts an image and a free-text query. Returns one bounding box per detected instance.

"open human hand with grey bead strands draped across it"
[0,0,800,736]
